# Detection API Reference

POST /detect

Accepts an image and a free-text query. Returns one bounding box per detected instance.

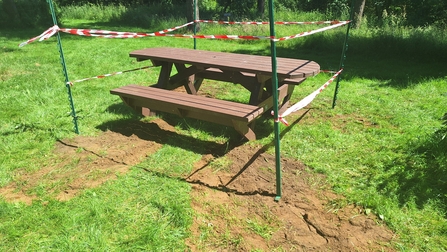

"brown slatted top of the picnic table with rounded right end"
[129,47,320,79]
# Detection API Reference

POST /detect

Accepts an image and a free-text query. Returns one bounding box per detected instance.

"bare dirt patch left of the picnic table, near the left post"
[0,131,161,204]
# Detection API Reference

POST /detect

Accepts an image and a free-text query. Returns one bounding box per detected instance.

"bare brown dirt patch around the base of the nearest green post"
[187,145,394,251]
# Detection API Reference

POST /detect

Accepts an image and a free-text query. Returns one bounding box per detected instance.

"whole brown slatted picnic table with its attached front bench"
[111,47,320,140]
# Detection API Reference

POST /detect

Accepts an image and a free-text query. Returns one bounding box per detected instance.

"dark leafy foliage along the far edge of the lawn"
[0,0,447,27]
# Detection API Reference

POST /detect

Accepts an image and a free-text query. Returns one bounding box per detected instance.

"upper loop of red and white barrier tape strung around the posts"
[19,20,350,47]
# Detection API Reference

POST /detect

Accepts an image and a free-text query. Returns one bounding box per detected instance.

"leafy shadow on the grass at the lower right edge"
[378,131,447,213]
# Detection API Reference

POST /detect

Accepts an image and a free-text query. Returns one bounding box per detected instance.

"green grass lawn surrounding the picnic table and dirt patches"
[0,4,447,251]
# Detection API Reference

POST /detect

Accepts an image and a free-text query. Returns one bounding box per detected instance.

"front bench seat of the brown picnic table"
[110,85,270,140]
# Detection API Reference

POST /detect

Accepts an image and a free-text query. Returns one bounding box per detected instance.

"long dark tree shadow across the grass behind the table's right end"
[235,33,447,89]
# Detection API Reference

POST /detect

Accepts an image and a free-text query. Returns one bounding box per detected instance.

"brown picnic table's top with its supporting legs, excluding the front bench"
[130,47,320,106]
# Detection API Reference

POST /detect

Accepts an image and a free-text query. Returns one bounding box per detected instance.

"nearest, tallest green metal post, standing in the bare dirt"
[269,0,282,201]
